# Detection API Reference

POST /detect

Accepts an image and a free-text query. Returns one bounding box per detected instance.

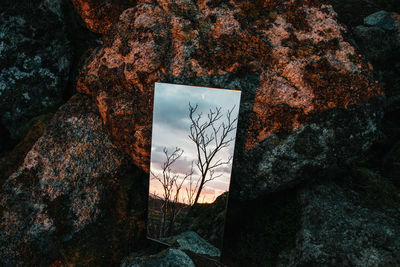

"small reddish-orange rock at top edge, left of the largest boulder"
[72,0,136,34]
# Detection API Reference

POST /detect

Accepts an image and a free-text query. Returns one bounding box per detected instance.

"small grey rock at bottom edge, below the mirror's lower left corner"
[121,248,195,267]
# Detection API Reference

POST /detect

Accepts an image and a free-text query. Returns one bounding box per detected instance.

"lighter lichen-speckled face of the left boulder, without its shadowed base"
[0,96,134,266]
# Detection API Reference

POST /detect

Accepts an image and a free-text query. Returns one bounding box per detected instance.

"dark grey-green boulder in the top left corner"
[0,0,72,139]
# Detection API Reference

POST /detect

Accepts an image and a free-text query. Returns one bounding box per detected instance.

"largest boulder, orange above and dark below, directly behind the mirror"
[78,0,383,201]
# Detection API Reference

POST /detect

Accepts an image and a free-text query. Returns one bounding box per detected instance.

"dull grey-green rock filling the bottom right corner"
[280,183,400,266]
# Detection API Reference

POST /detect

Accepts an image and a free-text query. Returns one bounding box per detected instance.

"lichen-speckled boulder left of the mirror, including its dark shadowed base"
[0,95,147,266]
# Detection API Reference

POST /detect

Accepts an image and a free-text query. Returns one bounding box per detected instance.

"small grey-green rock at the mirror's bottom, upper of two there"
[162,231,221,257]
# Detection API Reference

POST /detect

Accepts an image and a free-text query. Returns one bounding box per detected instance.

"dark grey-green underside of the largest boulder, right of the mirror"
[231,100,382,199]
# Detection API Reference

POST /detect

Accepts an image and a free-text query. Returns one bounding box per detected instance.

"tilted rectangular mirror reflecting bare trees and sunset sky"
[147,83,241,258]
